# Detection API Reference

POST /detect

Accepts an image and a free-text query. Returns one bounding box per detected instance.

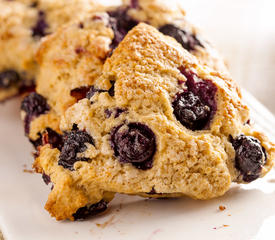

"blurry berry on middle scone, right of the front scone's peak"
[159,24,203,51]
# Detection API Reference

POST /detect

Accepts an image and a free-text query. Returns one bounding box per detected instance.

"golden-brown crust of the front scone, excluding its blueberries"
[31,24,275,220]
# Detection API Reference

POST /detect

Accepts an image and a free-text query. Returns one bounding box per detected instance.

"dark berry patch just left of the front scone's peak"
[108,7,138,49]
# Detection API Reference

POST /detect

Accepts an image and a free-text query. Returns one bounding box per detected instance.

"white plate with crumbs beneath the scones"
[0,93,275,240]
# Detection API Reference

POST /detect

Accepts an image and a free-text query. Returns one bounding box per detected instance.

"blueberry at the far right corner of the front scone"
[231,135,266,182]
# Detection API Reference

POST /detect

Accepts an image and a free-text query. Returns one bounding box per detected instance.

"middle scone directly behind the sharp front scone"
[22,0,227,154]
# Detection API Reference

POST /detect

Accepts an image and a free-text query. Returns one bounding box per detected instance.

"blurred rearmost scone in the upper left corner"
[0,0,101,101]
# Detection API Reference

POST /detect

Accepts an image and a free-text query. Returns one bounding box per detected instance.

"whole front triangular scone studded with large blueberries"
[31,24,275,220]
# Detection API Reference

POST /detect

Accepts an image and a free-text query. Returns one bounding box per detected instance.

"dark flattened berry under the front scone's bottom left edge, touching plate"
[73,200,108,220]
